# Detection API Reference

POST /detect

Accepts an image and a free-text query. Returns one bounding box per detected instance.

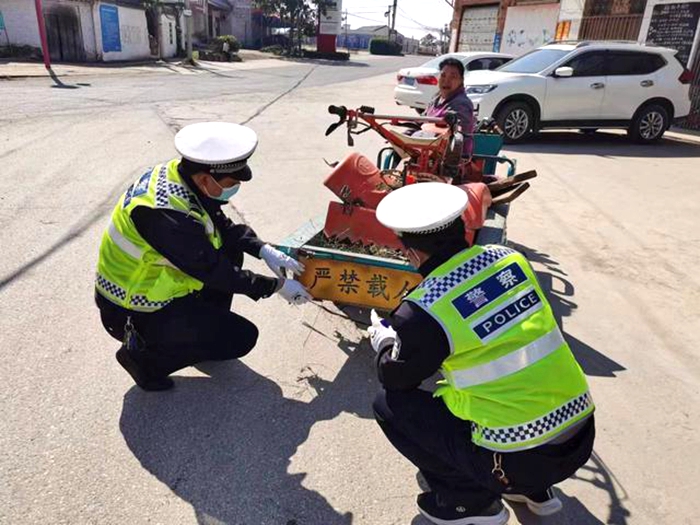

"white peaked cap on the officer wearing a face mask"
[175,122,258,180]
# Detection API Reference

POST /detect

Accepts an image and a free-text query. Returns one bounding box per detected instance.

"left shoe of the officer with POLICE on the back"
[418,492,510,525]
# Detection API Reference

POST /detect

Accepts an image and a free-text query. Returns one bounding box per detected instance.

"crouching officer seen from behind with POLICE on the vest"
[369,183,595,525]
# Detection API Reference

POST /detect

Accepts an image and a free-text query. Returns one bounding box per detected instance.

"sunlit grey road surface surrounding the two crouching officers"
[0,54,700,525]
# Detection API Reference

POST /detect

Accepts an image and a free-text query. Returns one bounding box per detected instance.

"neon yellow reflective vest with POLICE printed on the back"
[405,246,594,452]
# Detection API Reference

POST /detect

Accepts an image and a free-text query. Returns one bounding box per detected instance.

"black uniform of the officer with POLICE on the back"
[374,244,595,515]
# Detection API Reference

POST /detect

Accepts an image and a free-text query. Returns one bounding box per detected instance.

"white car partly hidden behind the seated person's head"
[394,52,513,112]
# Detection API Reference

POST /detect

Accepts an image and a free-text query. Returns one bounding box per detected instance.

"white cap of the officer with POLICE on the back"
[377,182,469,234]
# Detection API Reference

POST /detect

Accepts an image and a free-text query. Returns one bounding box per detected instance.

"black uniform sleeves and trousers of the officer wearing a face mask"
[95,167,278,379]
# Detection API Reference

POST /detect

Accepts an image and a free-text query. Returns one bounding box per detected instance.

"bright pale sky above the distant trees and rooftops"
[343,0,452,38]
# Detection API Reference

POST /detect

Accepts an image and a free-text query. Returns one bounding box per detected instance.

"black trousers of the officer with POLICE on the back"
[374,389,595,512]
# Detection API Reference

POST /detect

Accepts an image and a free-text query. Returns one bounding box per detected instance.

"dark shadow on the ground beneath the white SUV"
[504,131,700,158]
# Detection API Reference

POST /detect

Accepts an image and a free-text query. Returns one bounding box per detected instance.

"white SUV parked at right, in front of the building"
[464,41,692,143]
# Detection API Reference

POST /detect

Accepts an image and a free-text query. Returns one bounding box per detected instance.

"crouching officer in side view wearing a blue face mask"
[95,122,310,390]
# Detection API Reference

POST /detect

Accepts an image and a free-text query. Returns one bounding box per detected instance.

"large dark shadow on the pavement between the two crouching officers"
[120,334,376,525]
